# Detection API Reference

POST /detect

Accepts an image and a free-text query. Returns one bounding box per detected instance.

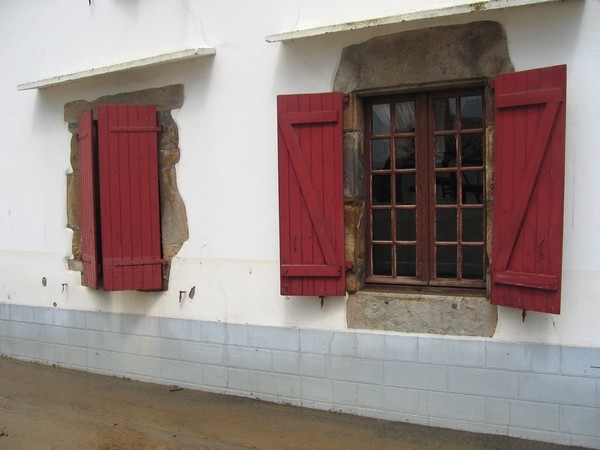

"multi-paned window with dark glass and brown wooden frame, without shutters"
[365,89,486,287]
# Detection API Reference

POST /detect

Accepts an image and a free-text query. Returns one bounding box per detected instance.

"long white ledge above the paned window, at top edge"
[265,0,566,42]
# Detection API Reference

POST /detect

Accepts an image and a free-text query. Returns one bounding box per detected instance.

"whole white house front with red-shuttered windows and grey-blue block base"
[0,0,600,448]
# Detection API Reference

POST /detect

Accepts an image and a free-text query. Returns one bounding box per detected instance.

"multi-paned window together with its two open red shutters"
[277,65,566,314]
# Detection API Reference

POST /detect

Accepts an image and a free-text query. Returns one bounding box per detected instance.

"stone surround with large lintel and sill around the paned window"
[334,22,514,336]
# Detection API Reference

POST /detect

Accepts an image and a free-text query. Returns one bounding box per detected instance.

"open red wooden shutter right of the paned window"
[491,66,566,314]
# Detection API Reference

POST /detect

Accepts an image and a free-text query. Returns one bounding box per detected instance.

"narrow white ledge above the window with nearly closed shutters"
[17,47,216,91]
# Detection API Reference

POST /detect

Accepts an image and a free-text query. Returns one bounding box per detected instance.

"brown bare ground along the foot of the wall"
[0,358,584,450]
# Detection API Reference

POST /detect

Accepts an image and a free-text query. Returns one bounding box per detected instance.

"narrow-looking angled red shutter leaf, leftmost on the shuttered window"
[77,110,100,289]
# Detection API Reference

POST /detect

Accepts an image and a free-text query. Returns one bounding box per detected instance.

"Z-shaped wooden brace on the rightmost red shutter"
[494,89,563,291]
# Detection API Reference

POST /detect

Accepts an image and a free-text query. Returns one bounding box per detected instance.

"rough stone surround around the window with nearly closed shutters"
[64,84,189,292]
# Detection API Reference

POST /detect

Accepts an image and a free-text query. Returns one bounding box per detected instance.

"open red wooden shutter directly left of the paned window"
[277,92,346,296]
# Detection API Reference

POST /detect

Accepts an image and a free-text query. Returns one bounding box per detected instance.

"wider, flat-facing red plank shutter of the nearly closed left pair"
[98,105,164,291]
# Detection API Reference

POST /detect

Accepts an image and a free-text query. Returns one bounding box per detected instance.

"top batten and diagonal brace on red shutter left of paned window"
[279,110,341,276]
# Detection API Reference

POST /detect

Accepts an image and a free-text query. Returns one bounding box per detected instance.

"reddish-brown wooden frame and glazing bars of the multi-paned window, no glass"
[363,86,489,291]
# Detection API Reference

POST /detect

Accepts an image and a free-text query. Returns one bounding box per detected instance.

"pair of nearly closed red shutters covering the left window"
[78,105,165,291]
